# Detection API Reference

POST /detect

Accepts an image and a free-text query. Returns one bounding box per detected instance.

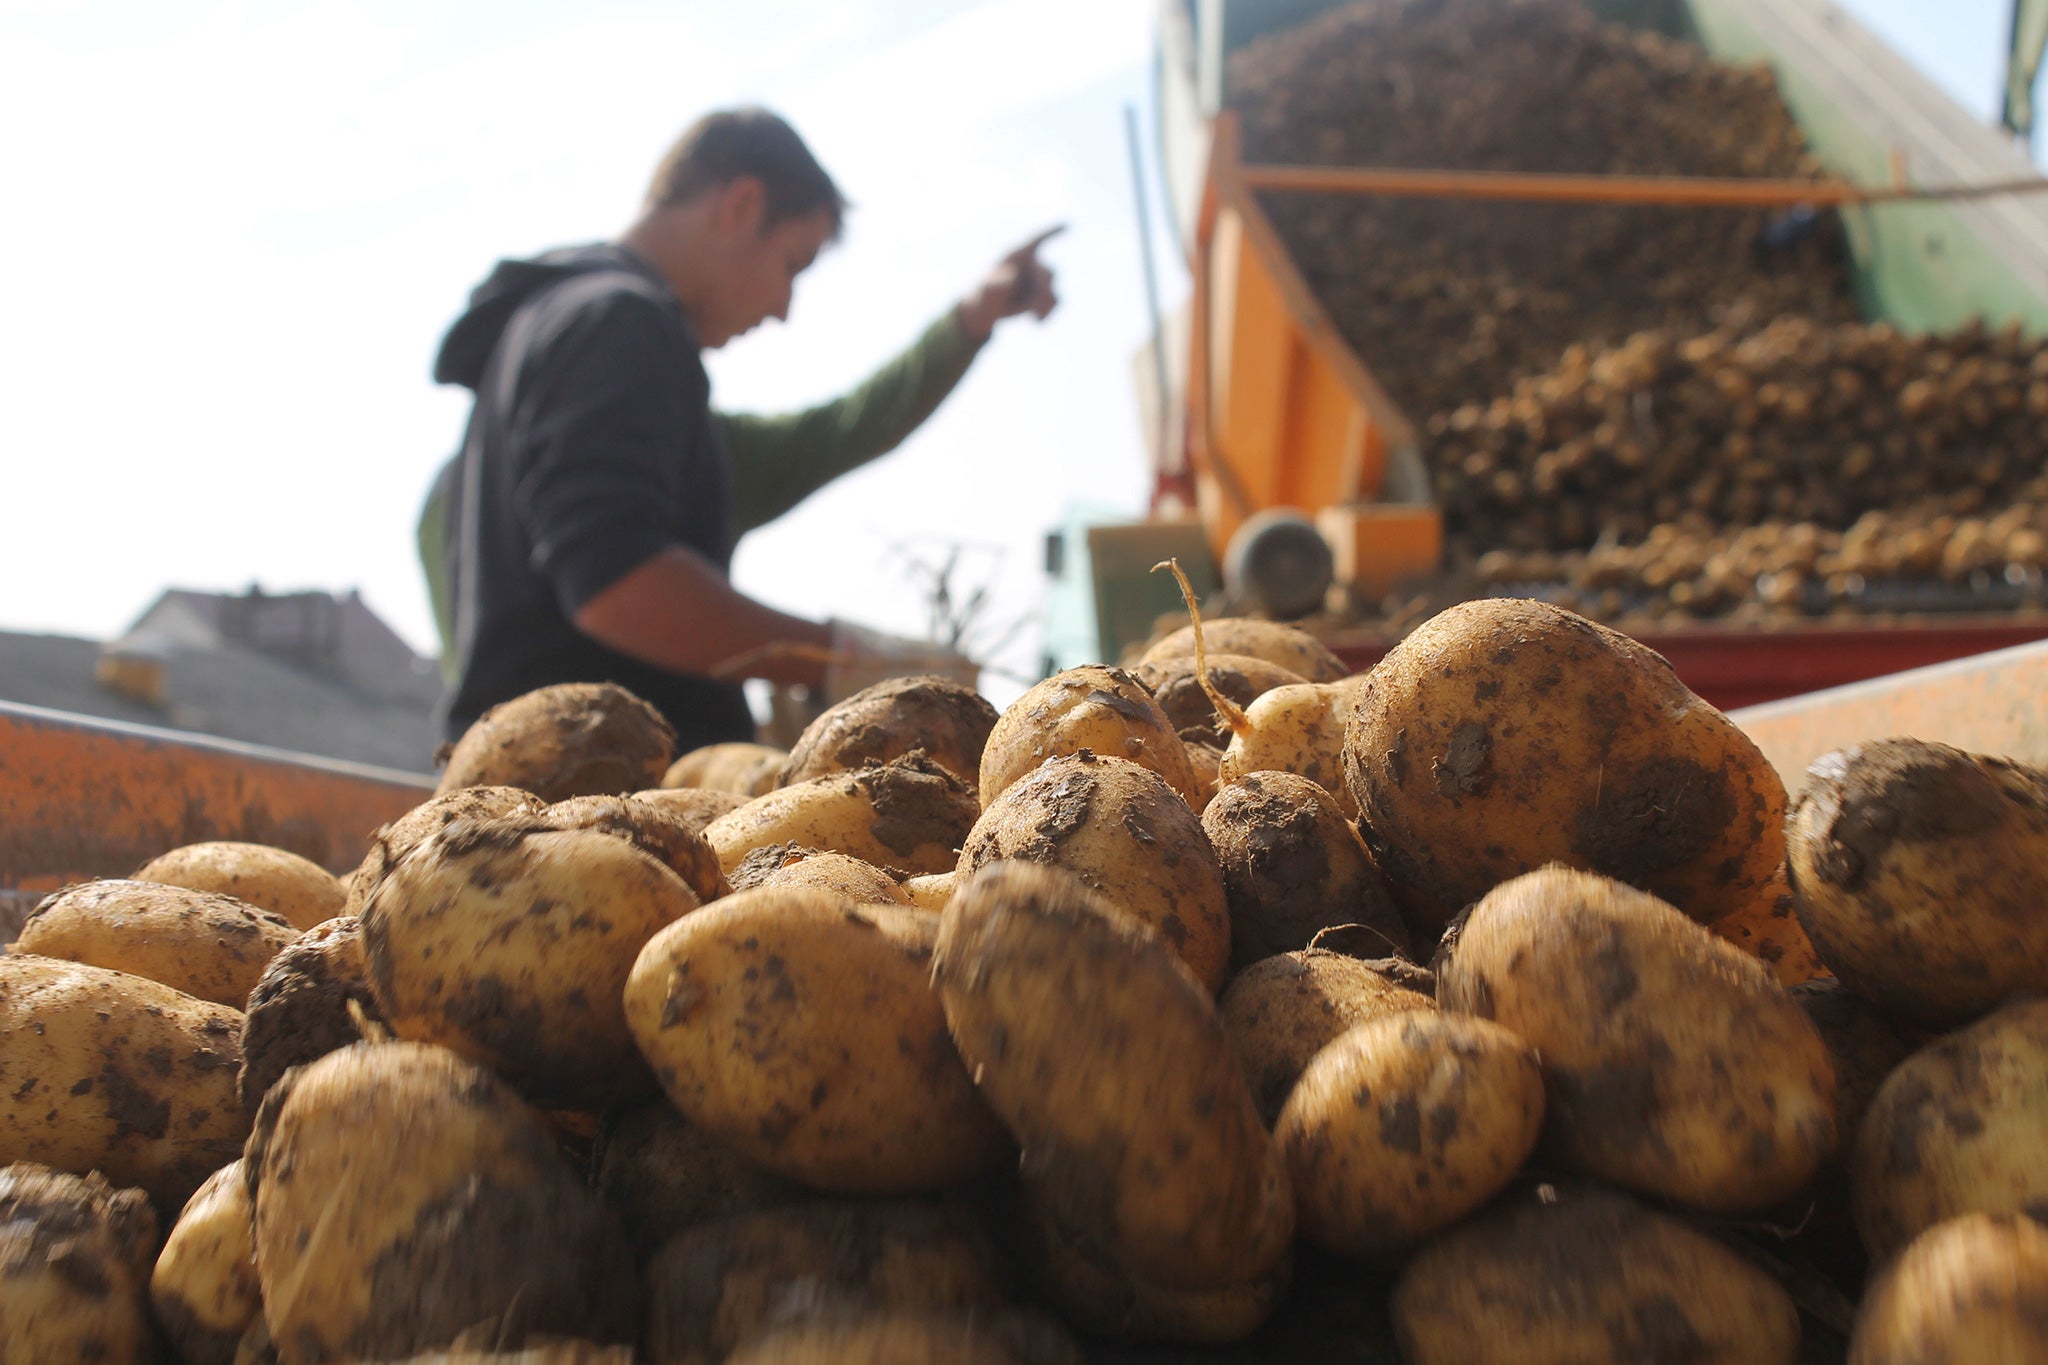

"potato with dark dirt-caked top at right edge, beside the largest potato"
[1788,739,2048,1023]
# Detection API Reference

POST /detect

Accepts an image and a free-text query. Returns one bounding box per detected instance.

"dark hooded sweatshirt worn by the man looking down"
[434,246,754,749]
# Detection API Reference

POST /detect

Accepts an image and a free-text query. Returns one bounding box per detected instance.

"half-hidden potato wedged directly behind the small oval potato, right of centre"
[1221,948,1436,1128]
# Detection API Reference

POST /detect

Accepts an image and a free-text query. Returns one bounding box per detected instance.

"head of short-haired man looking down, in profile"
[627,108,846,346]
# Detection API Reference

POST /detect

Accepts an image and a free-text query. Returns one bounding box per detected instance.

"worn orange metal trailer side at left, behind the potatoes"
[0,702,434,892]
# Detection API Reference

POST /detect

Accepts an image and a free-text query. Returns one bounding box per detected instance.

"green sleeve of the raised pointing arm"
[719,309,981,532]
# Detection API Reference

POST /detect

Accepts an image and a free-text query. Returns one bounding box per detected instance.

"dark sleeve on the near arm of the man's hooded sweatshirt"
[512,291,711,616]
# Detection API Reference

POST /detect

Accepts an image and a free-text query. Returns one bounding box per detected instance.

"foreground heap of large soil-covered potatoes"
[12,622,2048,1365]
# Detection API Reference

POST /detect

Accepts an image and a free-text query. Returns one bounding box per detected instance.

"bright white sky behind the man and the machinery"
[0,0,2007,692]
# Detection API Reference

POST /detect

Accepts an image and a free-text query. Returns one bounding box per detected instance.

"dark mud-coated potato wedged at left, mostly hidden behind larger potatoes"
[236,917,383,1117]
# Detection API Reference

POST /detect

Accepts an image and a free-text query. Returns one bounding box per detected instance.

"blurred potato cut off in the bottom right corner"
[1849,1214,2048,1365]
